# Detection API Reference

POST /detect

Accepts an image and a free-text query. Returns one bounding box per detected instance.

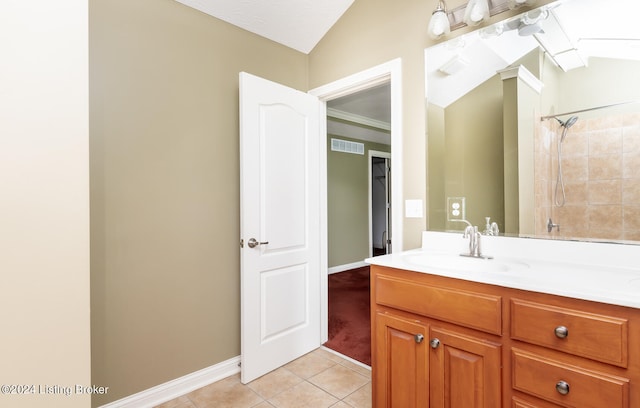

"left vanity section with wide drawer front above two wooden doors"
[371,266,502,408]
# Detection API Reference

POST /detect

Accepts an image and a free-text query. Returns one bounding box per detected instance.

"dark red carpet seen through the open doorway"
[324,266,371,365]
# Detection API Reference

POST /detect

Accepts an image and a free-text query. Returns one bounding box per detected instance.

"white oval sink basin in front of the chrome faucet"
[405,253,529,272]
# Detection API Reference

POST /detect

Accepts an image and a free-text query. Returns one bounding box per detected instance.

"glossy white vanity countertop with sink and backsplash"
[366,232,640,308]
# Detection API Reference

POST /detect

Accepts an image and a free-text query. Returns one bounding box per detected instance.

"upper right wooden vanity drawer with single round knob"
[511,299,628,367]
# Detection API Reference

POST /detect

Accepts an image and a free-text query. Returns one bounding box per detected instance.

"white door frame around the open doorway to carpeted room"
[309,58,403,343]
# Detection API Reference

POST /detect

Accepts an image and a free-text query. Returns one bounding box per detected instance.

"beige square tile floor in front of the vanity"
[156,348,371,408]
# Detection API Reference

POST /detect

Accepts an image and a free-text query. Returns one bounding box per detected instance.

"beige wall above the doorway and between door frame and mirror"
[309,0,550,249]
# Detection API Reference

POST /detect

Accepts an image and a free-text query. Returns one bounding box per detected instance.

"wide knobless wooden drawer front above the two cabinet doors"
[374,275,502,334]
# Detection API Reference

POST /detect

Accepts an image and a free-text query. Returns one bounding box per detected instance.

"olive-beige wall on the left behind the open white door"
[89,0,308,406]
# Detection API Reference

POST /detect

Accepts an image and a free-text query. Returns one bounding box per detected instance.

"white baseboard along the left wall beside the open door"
[100,356,240,408]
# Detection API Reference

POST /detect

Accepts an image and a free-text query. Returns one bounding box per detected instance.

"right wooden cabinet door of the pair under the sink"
[429,328,502,408]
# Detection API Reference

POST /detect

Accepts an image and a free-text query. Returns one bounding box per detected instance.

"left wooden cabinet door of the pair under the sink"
[373,312,429,408]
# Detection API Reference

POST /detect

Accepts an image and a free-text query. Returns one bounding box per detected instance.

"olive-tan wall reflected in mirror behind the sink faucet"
[428,75,504,230]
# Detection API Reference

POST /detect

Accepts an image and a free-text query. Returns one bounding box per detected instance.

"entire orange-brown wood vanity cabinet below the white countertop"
[371,265,640,408]
